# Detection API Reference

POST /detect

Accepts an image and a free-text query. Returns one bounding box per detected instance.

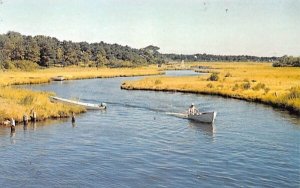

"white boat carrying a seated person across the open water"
[167,112,217,123]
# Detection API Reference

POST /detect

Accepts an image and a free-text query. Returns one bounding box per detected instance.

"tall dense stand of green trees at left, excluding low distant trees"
[0,32,164,68]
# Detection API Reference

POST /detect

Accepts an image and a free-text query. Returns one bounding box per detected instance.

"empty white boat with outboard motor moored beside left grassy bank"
[50,97,106,110]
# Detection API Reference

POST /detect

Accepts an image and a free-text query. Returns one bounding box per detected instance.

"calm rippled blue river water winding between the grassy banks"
[0,71,300,187]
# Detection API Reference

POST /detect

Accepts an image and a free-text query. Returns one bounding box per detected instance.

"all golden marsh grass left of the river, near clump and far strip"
[0,67,160,124]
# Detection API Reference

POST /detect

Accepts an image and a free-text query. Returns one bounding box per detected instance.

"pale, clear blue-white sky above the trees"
[0,0,300,56]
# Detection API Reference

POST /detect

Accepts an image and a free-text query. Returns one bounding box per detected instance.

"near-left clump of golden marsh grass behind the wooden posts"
[0,87,85,122]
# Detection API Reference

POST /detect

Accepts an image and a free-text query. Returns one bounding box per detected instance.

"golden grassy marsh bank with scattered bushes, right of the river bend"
[121,63,300,114]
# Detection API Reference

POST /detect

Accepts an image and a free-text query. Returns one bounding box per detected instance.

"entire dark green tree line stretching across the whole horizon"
[0,31,299,69]
